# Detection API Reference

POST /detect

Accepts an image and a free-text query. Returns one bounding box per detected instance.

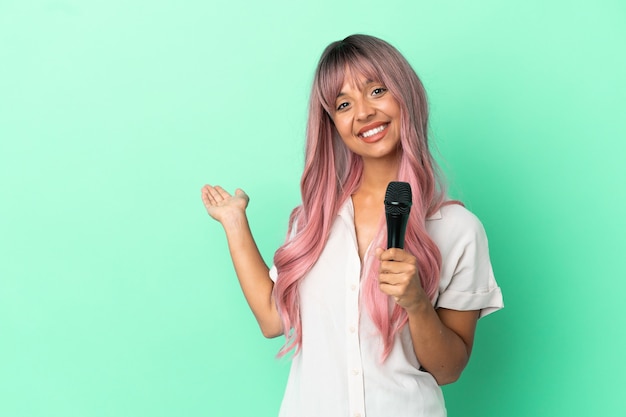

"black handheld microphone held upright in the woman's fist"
[385,181,413,249]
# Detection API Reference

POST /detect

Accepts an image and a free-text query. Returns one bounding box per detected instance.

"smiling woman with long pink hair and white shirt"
[202,35,503,417]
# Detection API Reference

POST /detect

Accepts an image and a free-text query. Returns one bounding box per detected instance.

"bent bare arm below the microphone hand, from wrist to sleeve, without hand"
[407,302,477,385]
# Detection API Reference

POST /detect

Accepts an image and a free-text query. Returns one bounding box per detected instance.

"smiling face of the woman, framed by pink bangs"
[331,71,400,161]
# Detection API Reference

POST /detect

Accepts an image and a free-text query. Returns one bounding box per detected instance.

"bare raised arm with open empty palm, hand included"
[202,185,283,338]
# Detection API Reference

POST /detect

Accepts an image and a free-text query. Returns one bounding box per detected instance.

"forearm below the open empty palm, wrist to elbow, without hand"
[222,212,283,337]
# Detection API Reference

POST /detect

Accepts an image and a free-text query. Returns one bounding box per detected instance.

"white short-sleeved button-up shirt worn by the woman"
[270,199,503,417]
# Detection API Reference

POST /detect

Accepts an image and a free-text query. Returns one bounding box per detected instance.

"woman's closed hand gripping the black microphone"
[376,248,430,312]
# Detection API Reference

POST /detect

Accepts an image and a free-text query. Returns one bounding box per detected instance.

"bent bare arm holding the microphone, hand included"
[378,249,478,385]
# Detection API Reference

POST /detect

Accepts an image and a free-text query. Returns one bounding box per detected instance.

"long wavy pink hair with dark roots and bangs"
[274,35,445,360]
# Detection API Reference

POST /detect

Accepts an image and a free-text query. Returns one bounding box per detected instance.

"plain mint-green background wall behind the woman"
[0,0,626,417]
